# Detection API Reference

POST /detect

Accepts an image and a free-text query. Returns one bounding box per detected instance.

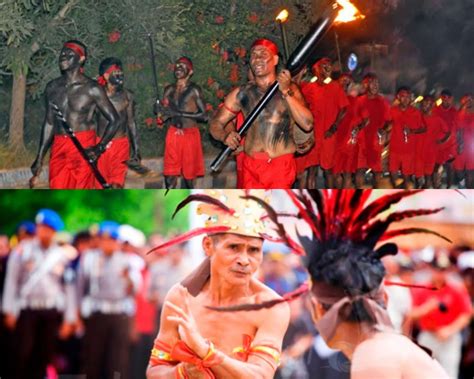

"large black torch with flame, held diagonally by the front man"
[211,0,364,171]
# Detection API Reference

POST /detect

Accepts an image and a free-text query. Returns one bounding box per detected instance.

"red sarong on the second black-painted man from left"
[98,137,130,187]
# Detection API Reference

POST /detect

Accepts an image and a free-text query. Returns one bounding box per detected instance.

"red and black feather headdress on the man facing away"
[211,190,451,311]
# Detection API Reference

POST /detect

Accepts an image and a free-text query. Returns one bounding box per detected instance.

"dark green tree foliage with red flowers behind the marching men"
[0,0,312,156]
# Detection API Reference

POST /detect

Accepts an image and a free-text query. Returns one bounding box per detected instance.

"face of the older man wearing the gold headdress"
[203,233,263,285]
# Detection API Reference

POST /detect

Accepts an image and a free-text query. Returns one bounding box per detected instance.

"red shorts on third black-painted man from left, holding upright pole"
[163,126,204,180]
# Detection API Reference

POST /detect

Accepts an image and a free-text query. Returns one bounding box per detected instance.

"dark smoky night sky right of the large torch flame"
[312,0,474,97]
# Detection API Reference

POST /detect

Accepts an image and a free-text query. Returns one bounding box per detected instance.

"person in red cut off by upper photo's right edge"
[454,94,474,188]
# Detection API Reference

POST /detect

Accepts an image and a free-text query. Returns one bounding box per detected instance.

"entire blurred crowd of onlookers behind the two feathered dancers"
[0,194,474,379]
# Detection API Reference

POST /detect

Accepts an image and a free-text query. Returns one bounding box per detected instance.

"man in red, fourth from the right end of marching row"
[389,87,426,188]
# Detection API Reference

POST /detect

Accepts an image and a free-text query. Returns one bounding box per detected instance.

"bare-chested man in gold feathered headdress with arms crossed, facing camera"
[147,190,290,379]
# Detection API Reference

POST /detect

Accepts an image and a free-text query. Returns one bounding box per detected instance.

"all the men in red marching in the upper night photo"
[26,38,474,189]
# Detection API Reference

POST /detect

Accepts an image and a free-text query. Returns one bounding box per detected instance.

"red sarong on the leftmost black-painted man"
[49,130,96,189]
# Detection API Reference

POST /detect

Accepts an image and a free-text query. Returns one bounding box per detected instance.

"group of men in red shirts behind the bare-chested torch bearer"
[296,58,474,188]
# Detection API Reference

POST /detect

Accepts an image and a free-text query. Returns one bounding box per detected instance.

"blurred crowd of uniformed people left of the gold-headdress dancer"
[0,209,192,379]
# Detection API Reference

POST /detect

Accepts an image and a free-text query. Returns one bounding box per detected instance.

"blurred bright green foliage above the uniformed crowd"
[0,190,188,235]
